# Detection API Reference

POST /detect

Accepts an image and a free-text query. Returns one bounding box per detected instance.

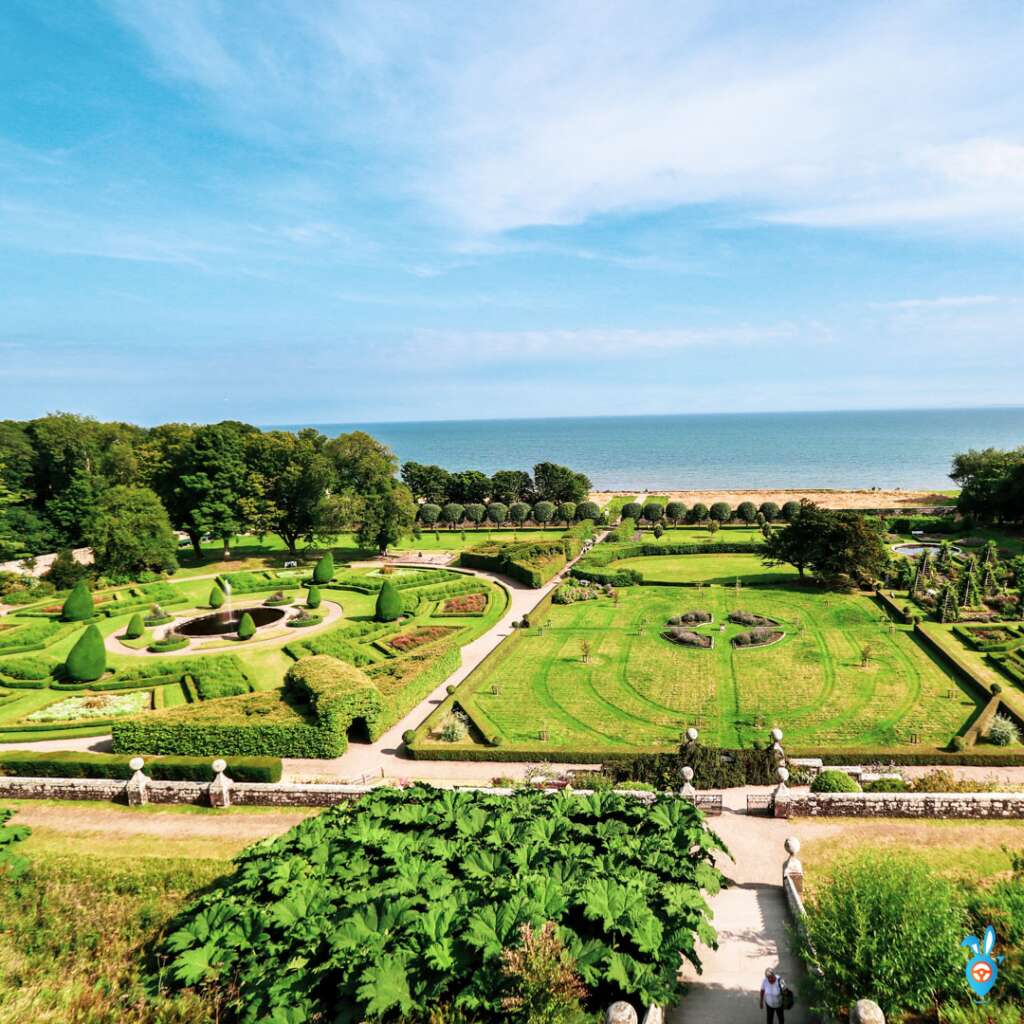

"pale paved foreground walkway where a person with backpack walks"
[666,788,817,1024]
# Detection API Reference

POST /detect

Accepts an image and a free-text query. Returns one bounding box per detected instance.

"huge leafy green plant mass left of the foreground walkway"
[165,786,724,1024]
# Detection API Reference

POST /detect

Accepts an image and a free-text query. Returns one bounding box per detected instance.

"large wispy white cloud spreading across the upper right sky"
[108,0,1024,232]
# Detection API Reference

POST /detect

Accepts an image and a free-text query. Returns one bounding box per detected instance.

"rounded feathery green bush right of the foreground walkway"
[800,853,968,1018]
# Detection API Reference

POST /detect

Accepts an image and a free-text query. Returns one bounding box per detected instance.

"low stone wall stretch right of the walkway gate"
[775,790,1024,818]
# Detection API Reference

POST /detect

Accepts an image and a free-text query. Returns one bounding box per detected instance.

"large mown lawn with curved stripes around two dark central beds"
[425,581,978,755]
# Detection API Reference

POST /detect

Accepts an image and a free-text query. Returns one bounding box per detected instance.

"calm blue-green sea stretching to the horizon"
[272,407,1024,490]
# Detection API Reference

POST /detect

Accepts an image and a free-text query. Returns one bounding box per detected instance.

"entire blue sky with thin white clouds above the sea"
[0,0,1024,423]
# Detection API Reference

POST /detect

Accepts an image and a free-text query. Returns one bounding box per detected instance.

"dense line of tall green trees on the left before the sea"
[0,413,590,574]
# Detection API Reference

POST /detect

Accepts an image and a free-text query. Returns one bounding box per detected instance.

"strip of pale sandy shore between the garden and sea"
[590,487,956,510]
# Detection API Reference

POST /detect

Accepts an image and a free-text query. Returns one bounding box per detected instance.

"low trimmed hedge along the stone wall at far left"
[0,751,282,782]
